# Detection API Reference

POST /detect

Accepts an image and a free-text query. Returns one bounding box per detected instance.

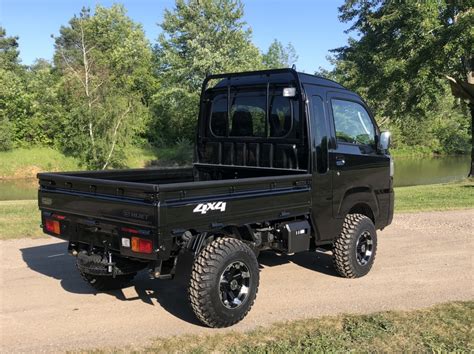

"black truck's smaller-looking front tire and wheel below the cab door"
[333,214,377,278]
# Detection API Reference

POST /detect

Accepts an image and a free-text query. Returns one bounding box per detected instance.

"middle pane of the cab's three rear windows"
[229,92,267,137]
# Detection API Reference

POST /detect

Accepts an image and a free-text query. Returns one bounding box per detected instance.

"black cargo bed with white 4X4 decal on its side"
[38,168,311,258]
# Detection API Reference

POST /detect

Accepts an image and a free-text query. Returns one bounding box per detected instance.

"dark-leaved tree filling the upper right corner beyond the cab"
[334,0,474,155]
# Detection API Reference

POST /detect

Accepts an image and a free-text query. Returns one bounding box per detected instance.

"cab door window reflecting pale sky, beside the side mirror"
[331,99,375,145]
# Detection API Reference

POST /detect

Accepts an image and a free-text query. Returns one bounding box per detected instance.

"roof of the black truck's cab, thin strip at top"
[206,69,346,89]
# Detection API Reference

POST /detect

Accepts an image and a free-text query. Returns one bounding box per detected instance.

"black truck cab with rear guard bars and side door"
[194,69,394,246]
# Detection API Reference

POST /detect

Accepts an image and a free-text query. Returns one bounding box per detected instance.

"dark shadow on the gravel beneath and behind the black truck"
[21,242,336,326]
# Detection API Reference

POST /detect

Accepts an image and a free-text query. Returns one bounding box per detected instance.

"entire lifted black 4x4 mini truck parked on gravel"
[38,69,394,327]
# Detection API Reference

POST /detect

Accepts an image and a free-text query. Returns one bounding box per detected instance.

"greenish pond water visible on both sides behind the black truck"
[0,156,471,200]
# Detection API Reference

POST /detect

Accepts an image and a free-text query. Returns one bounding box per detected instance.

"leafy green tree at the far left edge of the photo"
[0,28,64,150]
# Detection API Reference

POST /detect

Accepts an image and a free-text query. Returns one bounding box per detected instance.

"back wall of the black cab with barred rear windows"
[198,80,308,169]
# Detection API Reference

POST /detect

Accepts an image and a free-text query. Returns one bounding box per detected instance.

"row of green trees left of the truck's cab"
[0,0,296,168]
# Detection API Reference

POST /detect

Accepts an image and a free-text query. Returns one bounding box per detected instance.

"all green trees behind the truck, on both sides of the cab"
[0,0,474,168]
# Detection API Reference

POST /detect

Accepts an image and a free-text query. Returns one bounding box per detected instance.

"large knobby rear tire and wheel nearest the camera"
[188,237,259,328]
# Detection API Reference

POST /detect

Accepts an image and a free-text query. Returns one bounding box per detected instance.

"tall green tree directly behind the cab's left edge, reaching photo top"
[152,0,263,143]
